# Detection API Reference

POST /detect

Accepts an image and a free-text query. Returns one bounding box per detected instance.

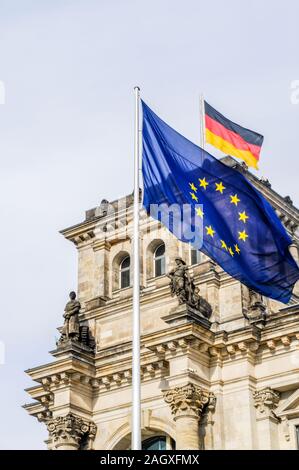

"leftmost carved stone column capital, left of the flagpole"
[47,413,97,450]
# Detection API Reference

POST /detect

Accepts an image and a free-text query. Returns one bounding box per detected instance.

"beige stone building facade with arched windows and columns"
[25,157,299,450]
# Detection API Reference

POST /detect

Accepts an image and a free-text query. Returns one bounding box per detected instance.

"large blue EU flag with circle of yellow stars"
[142,102,299,303]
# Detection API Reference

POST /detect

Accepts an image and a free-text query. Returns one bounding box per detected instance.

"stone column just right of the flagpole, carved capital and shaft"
[163,383,209,450]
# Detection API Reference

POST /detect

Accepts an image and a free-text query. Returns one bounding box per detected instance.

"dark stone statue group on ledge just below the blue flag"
[167,258,212,318]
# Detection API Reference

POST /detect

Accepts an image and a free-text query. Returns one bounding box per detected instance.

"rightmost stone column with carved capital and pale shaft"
[253,387,279,450]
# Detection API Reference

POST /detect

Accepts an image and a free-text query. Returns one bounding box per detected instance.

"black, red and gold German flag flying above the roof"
[205,101,264,169]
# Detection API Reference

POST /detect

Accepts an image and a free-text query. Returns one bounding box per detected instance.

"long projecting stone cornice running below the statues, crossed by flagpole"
[26,308,299,394]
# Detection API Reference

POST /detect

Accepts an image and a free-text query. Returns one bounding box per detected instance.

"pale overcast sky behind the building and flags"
[0,0,299,449]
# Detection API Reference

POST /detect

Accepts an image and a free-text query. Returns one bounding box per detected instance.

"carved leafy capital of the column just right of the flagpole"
[163,383,211,420]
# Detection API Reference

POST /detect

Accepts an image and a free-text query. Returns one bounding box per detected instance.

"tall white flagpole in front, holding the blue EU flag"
[131,86,141,450]
